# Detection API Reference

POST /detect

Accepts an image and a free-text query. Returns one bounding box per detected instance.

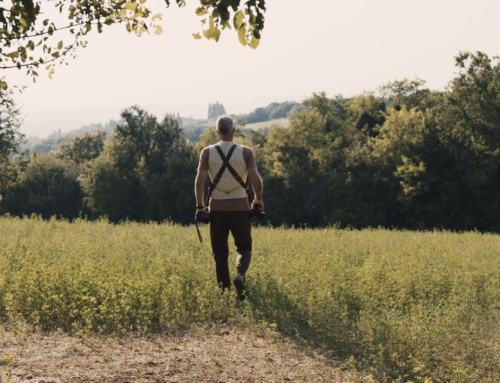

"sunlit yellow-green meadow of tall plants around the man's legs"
[0,217,500,383]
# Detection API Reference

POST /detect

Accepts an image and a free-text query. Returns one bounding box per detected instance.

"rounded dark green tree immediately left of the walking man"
[81,106,196,222]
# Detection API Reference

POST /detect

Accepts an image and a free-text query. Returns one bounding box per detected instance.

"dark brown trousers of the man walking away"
[210,211,252,289]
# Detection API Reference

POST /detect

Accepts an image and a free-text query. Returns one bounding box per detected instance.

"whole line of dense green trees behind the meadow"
[0,52,500,232]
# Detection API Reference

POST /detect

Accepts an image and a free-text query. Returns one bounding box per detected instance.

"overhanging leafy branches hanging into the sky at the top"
[0,0,266,90]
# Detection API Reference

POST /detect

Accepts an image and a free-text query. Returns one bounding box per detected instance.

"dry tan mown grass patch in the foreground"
[0,327,355,383]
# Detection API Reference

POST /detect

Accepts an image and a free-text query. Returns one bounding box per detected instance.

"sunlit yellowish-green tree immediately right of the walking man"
[255,93,349,226]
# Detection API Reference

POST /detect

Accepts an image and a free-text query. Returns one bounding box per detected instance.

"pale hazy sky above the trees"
[4,0,500,137]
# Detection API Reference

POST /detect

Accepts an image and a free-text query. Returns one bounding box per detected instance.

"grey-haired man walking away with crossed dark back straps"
[195,116,264,300]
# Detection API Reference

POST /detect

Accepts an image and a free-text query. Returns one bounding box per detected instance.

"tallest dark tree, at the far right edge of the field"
[407,52,500,231]
